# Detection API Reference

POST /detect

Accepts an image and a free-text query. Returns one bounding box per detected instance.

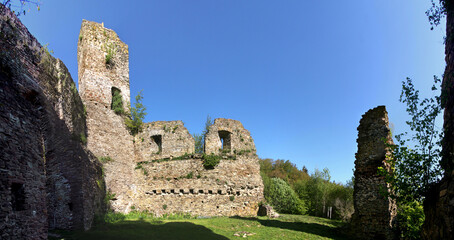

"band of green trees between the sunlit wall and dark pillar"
[259,159,353,221]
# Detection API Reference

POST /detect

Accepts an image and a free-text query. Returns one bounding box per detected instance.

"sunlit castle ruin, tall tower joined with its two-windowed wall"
[77,20,263,216]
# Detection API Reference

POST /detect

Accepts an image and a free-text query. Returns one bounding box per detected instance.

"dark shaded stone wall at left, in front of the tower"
[0,5,103,239]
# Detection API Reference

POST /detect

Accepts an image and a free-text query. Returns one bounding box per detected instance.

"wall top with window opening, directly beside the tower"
[134,121,195,162]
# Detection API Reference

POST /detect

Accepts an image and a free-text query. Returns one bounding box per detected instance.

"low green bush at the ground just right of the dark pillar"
[397,201,425,240]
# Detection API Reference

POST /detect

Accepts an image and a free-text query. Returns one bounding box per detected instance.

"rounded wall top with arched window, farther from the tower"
[205,118,256,155]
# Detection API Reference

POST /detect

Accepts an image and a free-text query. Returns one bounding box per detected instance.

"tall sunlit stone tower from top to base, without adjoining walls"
[77,20,135,212]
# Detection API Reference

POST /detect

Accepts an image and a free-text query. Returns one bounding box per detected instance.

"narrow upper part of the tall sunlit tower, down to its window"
[77,20,130,111]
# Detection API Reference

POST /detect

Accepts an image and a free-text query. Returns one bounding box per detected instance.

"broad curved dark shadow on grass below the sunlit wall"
[54,220,228,240]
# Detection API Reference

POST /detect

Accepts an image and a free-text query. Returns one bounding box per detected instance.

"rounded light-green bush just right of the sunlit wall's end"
[264,178,307,214]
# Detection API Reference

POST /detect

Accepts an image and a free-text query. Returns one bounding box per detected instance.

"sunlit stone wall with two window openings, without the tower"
[130,119,263,216]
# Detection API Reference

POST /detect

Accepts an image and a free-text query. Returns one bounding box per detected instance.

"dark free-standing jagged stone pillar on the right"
[351,106,396,239]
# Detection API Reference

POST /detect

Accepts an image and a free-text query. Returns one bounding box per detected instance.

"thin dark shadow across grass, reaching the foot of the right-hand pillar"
[231,216,350,240]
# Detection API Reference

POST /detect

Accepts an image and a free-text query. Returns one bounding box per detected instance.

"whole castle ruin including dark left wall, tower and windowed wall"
[0,4,263,239]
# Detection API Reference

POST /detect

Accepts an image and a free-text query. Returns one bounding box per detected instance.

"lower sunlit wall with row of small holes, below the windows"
[130,156,263,216]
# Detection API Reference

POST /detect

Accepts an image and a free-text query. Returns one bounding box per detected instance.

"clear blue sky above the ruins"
[16,0,445,182]
